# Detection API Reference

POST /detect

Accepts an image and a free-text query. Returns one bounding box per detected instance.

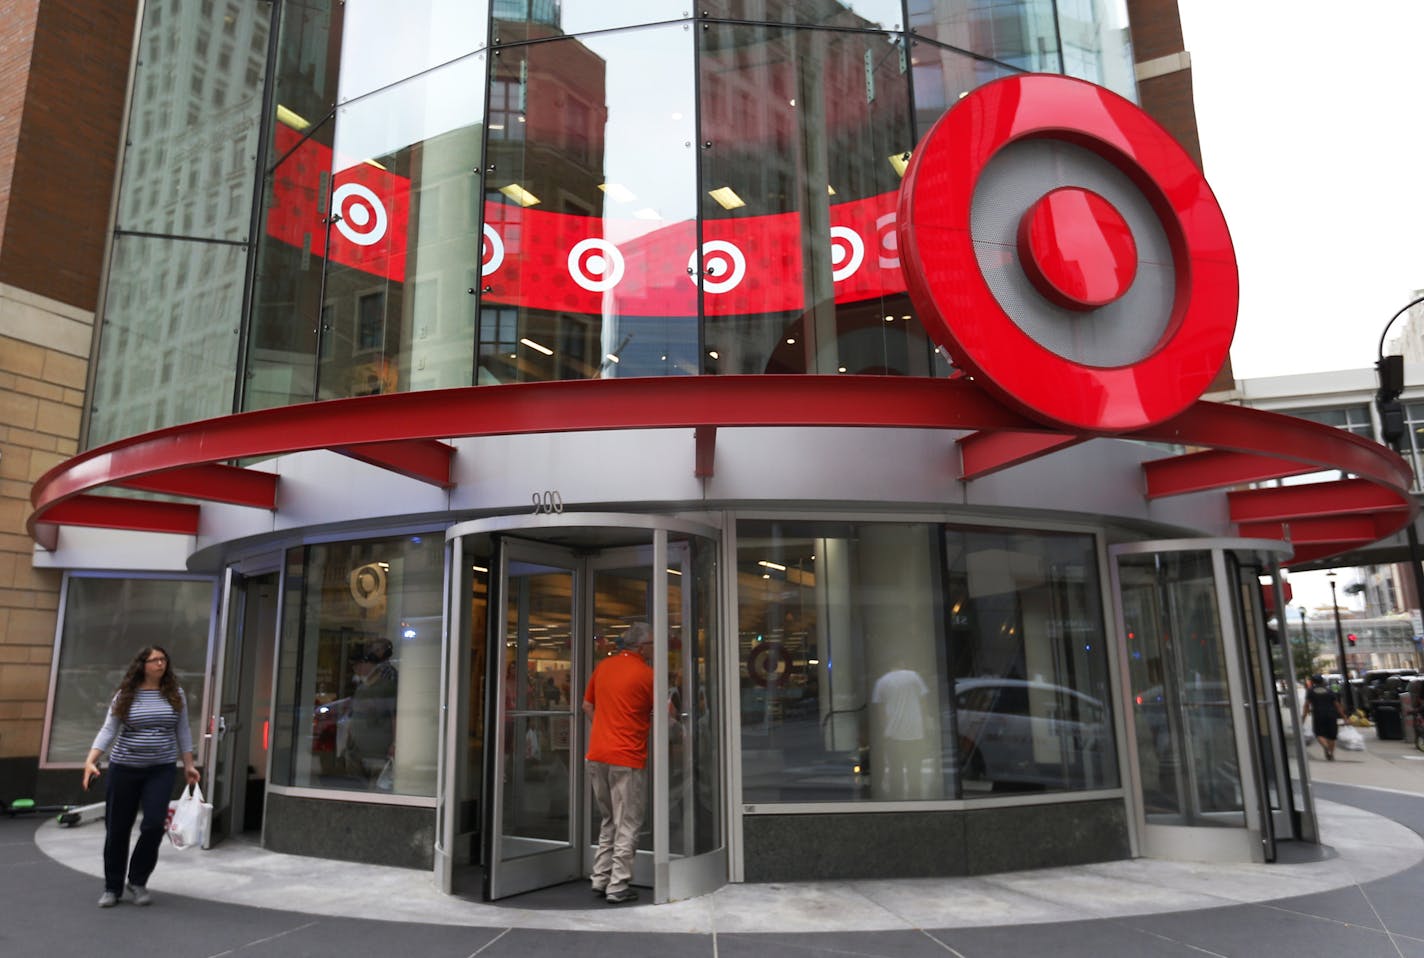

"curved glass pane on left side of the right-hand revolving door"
[1118,552,1246,826]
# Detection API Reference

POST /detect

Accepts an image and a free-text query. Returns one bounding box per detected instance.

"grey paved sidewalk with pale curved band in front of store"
[8,729,1424,958]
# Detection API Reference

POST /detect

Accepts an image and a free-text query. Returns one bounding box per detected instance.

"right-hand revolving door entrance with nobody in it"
[1112,541,1304,861]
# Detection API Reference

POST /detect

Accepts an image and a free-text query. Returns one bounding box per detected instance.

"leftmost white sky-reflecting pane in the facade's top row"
[336,0,490,102]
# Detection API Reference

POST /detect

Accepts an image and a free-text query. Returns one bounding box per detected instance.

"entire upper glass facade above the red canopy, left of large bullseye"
[85,0,1134,447]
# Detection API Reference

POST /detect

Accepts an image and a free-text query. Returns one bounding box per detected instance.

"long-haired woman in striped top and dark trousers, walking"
[84,645,198,908]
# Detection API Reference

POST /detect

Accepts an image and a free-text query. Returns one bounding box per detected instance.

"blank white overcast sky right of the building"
[1179,0,1424,379]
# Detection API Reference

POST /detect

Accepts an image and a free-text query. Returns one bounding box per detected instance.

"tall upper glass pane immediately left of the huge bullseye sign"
[699,24,934,376]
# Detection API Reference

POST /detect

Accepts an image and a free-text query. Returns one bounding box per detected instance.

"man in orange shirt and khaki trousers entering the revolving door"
[584,622,652,905]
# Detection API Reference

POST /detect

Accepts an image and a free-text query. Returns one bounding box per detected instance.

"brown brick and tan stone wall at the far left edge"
[0,0,137,774]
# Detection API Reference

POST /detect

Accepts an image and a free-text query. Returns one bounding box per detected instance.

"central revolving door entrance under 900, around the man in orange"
[436,517,726,901]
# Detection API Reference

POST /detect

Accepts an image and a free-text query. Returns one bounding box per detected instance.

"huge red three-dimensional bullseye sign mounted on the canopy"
[899,74,1237,433]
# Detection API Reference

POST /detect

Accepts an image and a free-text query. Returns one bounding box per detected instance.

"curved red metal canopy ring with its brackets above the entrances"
[28,376,1417,569]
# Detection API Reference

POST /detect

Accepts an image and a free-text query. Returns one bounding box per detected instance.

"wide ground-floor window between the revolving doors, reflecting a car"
[738,521,1118,803]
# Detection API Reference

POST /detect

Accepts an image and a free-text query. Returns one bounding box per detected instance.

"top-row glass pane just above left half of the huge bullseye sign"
[910,0,1065,73]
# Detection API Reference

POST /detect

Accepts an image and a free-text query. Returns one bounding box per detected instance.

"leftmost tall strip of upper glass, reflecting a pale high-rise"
[85,0,271,448]
